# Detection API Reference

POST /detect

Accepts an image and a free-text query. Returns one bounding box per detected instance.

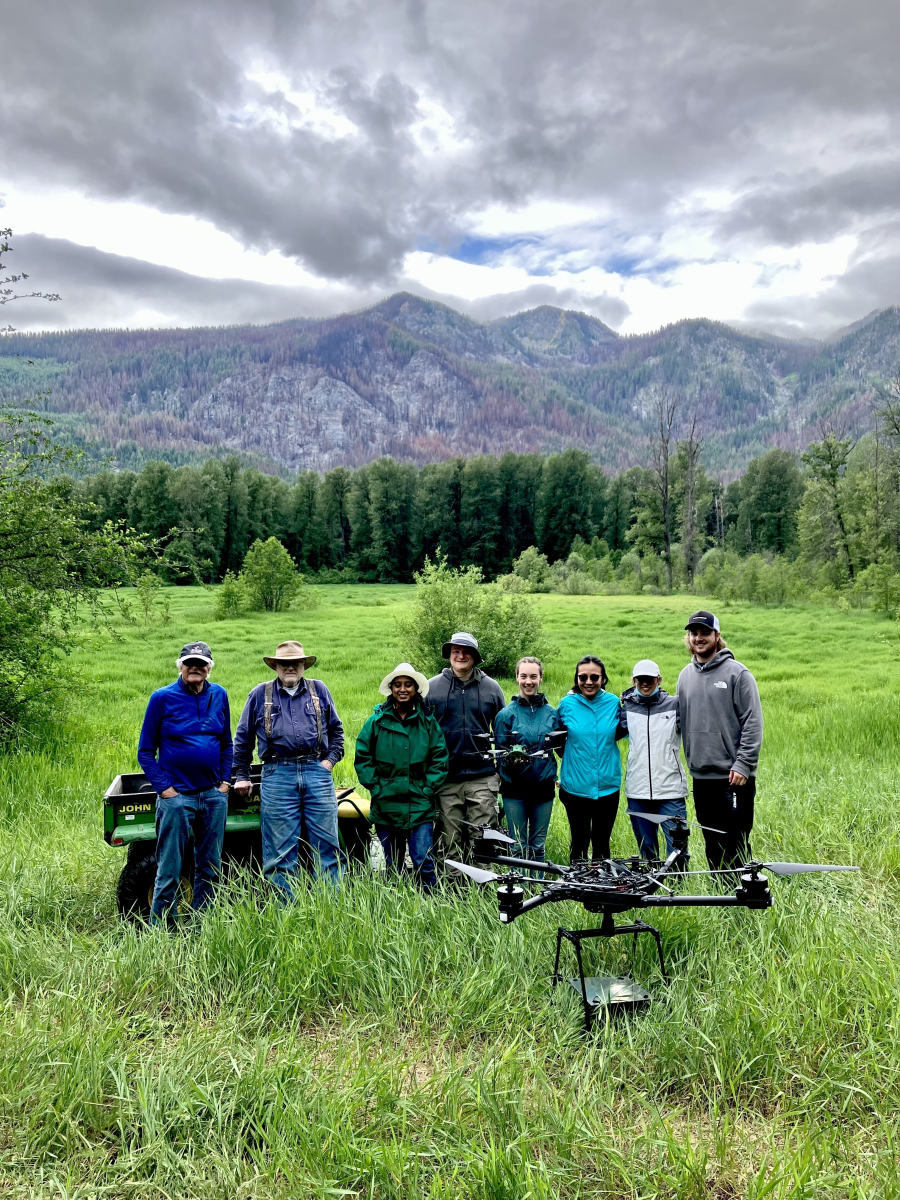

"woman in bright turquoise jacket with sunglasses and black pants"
[559,654,626,863]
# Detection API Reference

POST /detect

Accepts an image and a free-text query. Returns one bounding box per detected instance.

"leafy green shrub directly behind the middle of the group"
[396,558,558,676]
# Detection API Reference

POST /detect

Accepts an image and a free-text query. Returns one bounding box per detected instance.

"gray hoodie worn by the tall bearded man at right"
[678,650,762,779]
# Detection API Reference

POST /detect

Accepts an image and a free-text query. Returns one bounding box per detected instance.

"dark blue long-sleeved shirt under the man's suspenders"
[234,678,343,779]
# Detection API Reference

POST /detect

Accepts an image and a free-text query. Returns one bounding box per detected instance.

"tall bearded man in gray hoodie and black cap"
[678,610,762,871]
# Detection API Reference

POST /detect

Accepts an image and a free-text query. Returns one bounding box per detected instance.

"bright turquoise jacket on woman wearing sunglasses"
[559,691,626,800]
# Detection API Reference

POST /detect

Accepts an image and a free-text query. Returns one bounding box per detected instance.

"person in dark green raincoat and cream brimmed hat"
[354,662,449,892]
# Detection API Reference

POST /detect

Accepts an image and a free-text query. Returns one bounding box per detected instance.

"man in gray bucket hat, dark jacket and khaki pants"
[428,632,506,858]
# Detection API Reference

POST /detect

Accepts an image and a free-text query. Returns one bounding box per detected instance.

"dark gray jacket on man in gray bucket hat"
[428,667,506,781]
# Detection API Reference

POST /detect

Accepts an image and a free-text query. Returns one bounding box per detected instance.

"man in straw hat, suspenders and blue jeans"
[234,642,343,896]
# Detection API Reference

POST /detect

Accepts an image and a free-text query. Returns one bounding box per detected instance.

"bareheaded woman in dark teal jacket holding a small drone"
[493,656,562,862]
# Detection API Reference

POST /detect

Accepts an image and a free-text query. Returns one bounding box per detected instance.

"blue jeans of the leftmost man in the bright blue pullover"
[150,787,228,925]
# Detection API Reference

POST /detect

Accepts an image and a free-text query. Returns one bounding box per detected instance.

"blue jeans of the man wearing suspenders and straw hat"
[259,758,341,898]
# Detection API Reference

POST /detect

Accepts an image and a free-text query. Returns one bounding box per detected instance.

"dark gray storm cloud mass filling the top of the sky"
[0,0,900,324]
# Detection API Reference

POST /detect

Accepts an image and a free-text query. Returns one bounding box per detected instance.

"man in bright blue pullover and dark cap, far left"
[138,642,232,924]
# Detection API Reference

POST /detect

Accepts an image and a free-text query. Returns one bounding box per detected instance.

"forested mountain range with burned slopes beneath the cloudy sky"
[0,294,900,474]
